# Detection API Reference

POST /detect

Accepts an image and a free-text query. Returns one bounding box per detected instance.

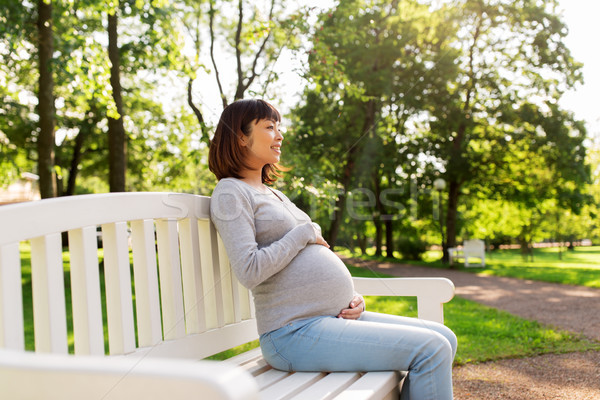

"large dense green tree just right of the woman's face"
[292,1,452,248]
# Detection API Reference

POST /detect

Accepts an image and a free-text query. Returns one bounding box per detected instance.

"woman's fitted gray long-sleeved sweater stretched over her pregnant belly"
[210,178,354,334]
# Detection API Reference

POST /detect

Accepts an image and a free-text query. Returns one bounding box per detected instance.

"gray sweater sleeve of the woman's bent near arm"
[210,184,316,289]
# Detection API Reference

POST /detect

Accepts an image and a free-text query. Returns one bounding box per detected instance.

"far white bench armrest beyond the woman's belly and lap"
[353,278,454,323]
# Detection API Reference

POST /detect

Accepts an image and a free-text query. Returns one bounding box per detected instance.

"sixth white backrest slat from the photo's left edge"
[156,220,185,340]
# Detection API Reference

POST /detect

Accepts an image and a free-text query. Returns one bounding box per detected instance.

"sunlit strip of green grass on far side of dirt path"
[336,246,600,288]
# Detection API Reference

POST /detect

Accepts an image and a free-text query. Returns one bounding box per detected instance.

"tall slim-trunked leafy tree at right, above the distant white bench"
[423,0,585,259]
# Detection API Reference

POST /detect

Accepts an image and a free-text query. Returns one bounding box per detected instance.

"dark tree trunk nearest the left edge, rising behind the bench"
[37,0,56,199]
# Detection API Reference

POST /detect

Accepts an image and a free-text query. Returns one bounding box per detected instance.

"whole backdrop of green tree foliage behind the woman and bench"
[0,0,600,258]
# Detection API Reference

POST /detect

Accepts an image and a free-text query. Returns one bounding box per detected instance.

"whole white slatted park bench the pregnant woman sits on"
[0,193,454,400]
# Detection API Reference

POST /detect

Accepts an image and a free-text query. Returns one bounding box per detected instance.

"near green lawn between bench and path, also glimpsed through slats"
[22,242,600,364]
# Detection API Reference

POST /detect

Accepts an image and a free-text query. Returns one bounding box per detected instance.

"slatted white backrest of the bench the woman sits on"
[0,193,258,359]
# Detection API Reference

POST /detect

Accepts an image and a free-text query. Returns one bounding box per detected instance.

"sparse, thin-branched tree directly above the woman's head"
[184,0,307,115]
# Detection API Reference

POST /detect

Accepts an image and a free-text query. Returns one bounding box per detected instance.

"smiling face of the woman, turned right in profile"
[242,119,283,169]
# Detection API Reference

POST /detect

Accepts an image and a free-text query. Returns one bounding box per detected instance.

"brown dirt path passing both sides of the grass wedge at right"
[344,259,600,400]
